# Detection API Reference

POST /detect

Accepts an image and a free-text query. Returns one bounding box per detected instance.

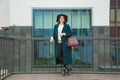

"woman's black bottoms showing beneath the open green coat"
[56,43,63,64]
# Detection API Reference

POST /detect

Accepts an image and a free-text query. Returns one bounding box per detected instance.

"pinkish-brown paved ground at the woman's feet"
[5,74,120,80]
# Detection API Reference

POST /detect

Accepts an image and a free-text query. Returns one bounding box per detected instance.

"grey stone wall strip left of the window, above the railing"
[0,26,32,37]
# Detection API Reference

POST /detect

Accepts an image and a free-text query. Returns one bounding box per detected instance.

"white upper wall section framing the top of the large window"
[10,0,110,26]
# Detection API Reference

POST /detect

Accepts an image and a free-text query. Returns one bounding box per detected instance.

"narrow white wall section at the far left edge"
[0,0,9,29]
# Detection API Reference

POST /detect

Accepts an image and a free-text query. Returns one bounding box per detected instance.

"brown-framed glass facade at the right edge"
[110,0,120,65]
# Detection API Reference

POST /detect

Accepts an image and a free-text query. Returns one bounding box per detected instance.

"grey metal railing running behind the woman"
[0,36,120,79]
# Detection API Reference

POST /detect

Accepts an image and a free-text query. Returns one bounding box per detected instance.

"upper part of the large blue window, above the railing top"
[33,9,91,37]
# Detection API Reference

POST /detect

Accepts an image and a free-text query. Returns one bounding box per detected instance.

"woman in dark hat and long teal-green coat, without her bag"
[50,14,72,76]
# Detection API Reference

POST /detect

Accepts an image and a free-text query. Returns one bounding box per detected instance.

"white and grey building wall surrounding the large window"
[0,0,110,72]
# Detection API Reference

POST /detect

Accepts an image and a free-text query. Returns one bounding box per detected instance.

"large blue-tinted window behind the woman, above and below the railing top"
[33,9,92,65]
